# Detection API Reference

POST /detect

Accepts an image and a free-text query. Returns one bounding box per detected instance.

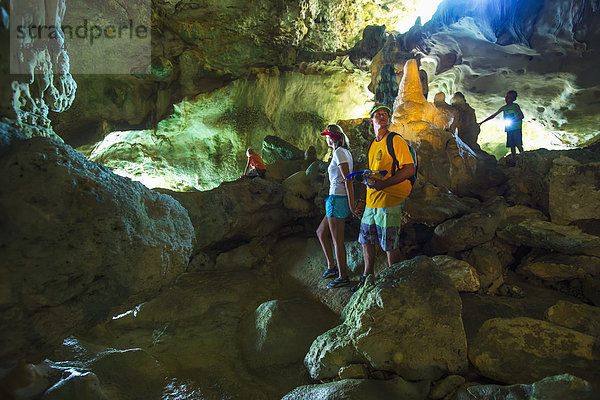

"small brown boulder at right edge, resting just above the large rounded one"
[546,300,600,337]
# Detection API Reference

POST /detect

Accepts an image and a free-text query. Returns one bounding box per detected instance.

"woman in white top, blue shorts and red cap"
[317,125,356,288]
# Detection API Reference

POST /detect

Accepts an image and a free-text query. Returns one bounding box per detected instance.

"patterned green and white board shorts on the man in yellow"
[358,203,404,251]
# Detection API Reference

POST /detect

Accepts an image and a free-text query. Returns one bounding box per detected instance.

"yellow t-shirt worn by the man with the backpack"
[367,132,414,208]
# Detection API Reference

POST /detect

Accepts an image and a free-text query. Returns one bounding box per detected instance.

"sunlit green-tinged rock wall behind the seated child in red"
[89,63,369,191]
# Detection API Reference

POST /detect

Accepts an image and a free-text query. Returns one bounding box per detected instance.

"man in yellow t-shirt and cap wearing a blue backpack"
[351,104,415,292]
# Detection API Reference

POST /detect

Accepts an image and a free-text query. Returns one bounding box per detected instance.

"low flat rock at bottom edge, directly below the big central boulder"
[282,377,429,400]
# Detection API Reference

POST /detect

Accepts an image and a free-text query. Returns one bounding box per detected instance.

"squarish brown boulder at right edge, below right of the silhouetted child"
[548,156,600,225]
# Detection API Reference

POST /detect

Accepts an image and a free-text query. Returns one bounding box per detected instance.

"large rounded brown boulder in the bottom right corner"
[469,317,600,384]
